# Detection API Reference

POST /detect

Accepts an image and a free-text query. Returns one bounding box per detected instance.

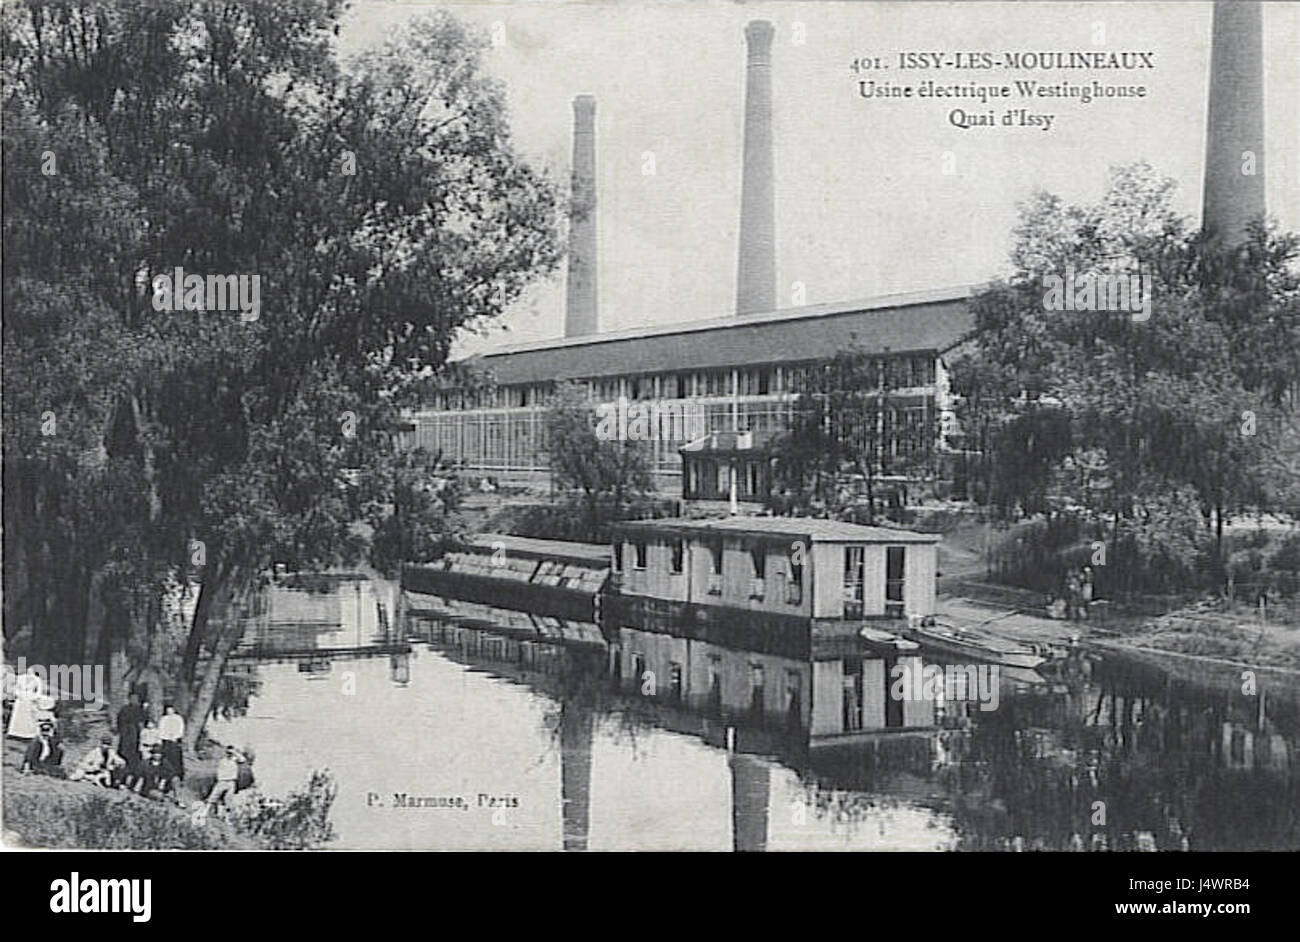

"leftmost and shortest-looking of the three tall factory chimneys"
[564,95,595,337]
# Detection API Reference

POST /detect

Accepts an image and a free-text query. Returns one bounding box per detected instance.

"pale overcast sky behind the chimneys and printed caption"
[343,0,1300,352]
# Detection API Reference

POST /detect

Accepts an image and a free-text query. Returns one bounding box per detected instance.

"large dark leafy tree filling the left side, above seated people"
[3,0,558,746]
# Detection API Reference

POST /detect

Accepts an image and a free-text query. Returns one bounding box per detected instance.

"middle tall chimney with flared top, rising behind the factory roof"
[736,19,776,314]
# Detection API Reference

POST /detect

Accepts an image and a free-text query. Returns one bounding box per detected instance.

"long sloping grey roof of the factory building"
[464,286,974,385]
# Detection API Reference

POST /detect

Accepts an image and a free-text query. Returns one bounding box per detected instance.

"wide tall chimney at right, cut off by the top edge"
[1201,0,1265,243]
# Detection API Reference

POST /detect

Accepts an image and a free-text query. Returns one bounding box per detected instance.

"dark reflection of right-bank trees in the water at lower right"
[939,685,1300,850]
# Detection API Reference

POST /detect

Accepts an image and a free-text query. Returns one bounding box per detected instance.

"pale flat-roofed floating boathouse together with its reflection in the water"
[606,517,939,742]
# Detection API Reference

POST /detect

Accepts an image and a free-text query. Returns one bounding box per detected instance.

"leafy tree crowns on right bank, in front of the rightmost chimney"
[952,164,1300,585]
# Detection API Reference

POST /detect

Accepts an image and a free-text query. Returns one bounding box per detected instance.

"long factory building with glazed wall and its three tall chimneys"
[411,1,1265,495]
